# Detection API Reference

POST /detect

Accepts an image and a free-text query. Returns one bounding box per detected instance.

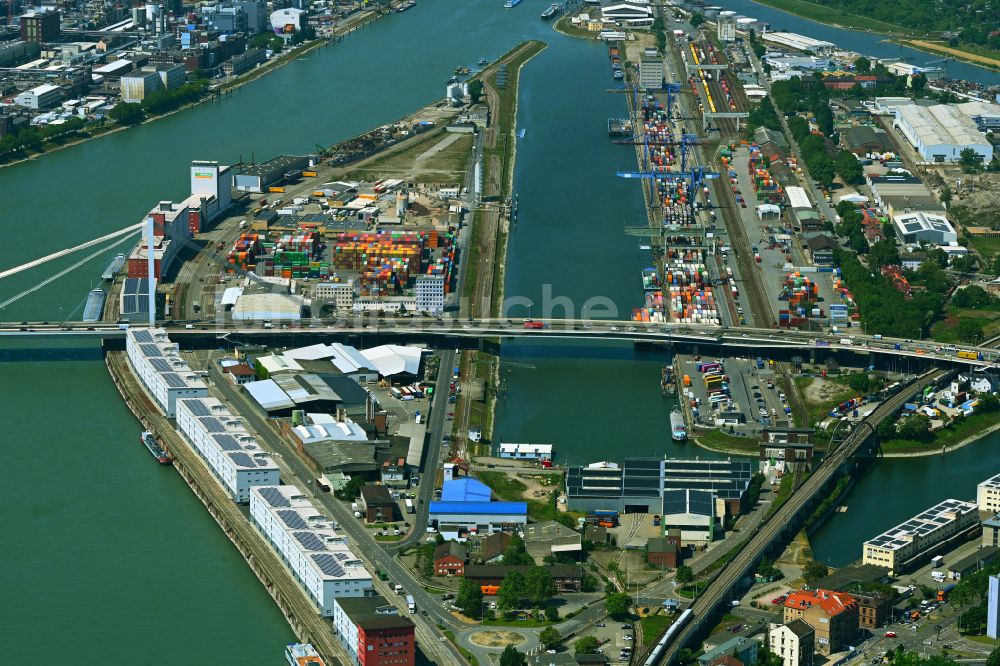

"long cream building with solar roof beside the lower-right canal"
[862,499,979,573]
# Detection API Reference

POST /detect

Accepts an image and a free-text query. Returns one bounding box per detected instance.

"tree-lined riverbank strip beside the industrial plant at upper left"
[0,11,388,169]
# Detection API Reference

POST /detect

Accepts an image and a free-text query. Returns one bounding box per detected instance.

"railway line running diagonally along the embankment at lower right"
[654,369,947,664]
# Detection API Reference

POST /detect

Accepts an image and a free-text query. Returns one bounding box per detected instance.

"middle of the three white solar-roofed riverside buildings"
[177,398,280,504]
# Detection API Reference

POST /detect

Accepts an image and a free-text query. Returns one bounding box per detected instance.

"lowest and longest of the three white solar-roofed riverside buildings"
[250,485,374,617]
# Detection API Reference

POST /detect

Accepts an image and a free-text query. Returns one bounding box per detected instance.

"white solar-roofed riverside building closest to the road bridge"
[125,328,208,418]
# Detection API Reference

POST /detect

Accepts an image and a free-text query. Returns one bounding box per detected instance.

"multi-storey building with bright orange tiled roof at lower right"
[784,589,858,655]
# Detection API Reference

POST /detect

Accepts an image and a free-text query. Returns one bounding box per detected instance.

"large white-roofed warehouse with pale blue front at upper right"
[893,104,993,164]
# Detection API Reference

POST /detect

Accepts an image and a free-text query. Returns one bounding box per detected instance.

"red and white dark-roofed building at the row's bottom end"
[333,595,417,666]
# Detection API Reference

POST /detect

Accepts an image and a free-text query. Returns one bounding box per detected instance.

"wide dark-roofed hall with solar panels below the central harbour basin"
[566,458,753,517]
